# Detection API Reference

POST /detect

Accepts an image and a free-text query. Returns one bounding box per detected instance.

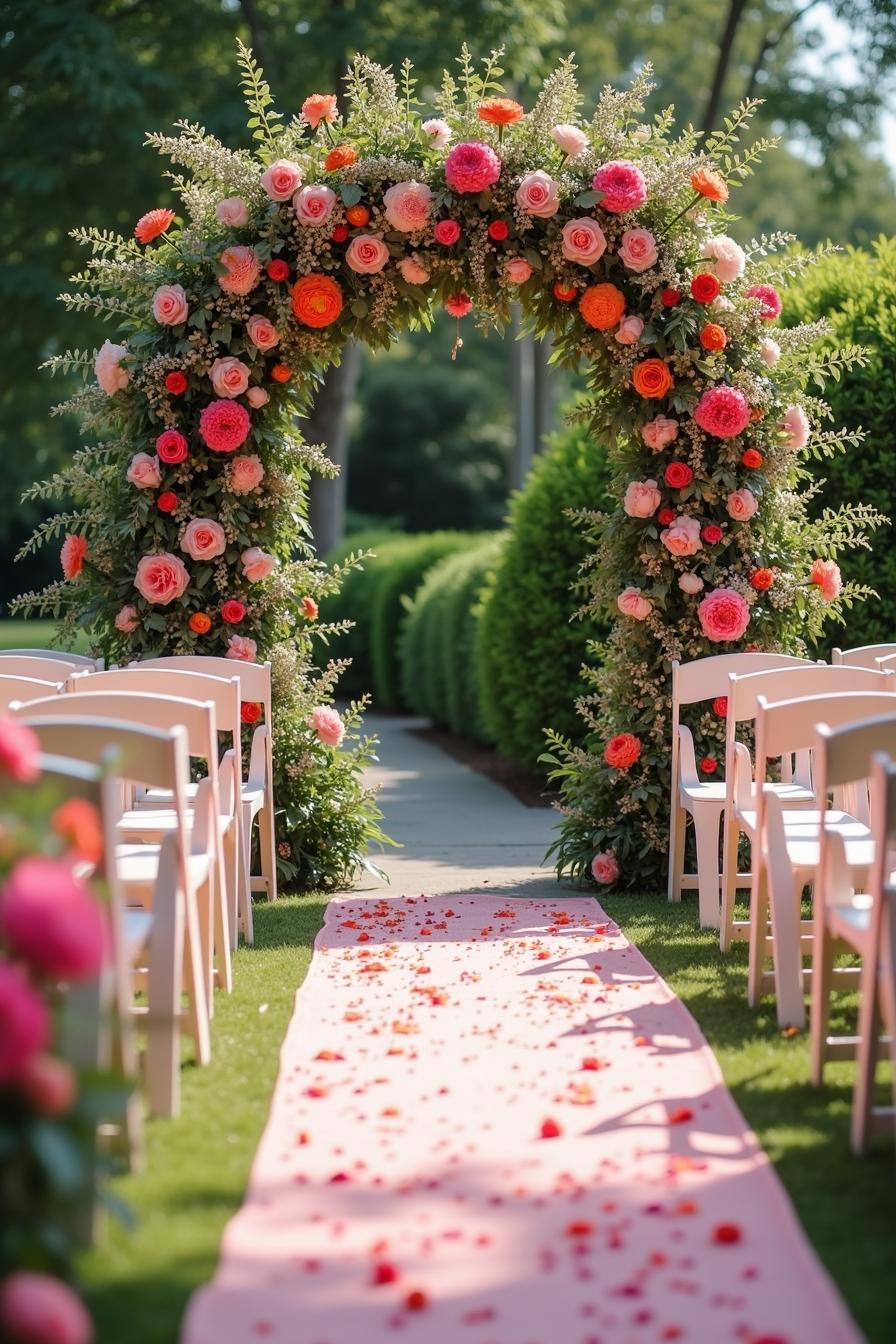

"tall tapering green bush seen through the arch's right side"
[477,425,609,767]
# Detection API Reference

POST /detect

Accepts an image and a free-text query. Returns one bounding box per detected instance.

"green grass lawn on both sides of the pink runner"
[82,896,896,1344]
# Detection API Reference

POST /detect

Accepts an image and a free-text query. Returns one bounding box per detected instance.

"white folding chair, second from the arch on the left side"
[67,664,253,950]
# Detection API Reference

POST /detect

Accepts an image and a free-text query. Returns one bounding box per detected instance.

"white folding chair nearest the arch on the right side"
[668,653,807,929]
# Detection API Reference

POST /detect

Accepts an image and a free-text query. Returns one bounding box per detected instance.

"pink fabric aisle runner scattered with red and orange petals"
[183,895,861,1344]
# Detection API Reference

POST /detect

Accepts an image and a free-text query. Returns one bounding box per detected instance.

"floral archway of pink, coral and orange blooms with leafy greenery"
[20,48,875,884]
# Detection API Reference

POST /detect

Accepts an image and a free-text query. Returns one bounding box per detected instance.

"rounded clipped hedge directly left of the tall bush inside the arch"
[402,535,505,741]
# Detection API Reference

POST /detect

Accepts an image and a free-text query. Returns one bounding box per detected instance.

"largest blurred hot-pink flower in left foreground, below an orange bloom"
[0,855,106,984]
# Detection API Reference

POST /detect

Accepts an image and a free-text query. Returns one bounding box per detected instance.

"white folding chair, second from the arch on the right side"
[719,663,896,952]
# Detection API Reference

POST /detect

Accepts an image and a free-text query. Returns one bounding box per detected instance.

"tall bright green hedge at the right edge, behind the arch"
[785,238,896,653]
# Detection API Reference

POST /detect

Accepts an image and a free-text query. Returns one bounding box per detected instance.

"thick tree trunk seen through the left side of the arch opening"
[306,341,361,555]
